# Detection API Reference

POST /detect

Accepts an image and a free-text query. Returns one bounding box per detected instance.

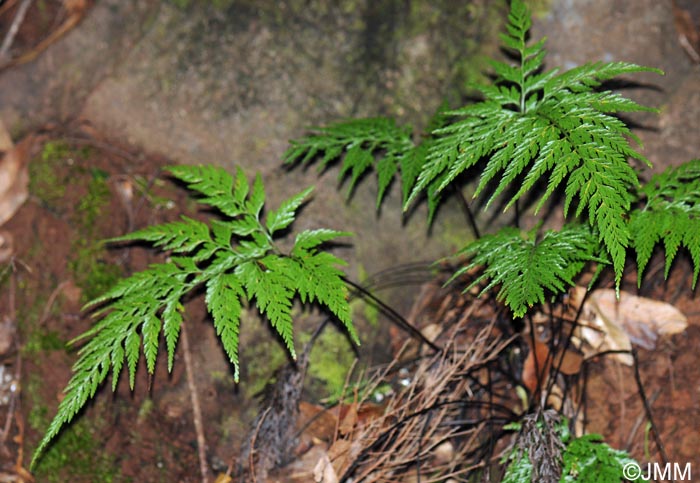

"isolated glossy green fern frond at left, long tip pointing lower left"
[32,166,359,465]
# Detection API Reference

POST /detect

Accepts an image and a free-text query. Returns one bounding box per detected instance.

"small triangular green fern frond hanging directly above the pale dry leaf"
[450,225,604,317]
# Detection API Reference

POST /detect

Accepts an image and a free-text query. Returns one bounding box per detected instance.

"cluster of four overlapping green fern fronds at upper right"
[285,0,700,322]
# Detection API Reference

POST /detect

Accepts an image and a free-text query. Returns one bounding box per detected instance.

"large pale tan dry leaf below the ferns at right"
[571,287,688,365]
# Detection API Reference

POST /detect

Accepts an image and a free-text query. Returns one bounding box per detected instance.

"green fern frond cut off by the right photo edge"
[629,159,700,288]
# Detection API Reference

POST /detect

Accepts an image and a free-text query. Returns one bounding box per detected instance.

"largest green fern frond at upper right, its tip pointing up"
[404,0,662,284]
